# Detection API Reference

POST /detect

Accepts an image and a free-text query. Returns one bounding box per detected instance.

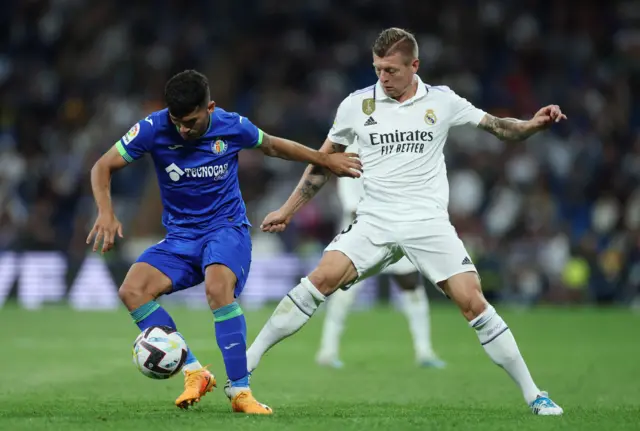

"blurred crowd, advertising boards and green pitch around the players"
[0,0,640,431]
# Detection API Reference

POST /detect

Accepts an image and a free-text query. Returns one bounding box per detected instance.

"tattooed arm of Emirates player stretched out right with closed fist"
[478,105,567,141]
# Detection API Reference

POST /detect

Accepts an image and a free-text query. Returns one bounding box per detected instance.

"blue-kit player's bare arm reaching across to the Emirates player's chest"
[258,133,362,178]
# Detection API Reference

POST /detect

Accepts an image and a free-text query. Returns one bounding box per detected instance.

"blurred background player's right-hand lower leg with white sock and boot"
[393,271,446,368]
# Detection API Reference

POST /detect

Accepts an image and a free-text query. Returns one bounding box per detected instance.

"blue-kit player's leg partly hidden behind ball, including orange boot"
[118,262,215,407]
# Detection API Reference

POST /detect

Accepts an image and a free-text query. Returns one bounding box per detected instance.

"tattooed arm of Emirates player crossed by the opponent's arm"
[260,139,346,233]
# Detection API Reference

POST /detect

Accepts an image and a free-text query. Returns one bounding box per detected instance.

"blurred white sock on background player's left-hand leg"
[318,283,362,359]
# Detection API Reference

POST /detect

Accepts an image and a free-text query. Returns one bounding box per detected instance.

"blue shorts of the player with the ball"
[136,225,251,298]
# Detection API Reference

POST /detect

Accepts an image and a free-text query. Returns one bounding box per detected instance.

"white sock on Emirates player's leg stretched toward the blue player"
[247,277,325,372]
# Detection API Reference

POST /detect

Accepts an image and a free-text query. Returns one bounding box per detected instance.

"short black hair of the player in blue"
[164,70,210,118]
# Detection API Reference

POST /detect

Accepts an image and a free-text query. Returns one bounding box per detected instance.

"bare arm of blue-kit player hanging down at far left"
[87,146,127,253]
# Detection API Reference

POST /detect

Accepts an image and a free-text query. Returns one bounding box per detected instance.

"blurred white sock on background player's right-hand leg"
[400,286,435,360]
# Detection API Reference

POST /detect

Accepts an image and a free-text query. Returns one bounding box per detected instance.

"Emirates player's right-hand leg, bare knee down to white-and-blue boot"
[440,272,563,415]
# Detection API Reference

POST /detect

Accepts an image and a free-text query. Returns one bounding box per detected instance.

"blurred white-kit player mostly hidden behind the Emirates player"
[316,143,446,368]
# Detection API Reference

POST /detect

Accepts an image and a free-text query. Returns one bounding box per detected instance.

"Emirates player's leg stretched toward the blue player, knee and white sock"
[247,251,358,371]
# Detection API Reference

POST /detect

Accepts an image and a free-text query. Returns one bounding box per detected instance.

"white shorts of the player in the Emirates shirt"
[325,216,477,284]
